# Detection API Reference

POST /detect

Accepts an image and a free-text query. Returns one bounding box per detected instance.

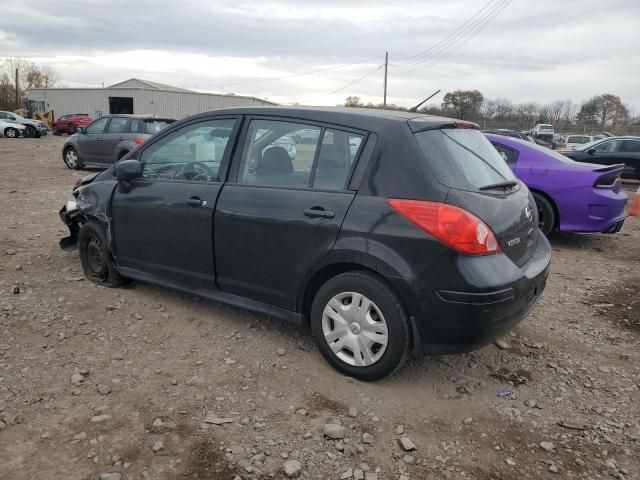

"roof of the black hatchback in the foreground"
[185,106,464,131]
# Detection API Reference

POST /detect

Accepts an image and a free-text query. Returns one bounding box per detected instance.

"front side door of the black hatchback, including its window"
[112,117,238,289]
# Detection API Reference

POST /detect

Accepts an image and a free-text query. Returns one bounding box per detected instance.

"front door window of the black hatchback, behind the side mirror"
[140,119,236,182]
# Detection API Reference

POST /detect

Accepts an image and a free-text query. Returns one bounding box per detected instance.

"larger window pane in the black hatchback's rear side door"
[238,120,321,188]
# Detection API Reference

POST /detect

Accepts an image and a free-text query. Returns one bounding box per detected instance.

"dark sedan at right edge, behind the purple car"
[564,137,640,180]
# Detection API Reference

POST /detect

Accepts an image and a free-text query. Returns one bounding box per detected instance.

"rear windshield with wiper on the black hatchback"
[416,128,516,191]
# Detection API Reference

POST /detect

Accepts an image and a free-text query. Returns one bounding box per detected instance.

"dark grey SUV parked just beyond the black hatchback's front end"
[62,115,175,170]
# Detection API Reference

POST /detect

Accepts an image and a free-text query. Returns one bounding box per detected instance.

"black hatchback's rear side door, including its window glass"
[214,118,365,310]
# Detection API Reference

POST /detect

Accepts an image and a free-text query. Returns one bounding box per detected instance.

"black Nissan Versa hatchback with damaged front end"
[60,107,551,380]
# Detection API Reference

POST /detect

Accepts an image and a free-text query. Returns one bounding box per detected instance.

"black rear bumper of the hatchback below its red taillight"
[392,232,551,354]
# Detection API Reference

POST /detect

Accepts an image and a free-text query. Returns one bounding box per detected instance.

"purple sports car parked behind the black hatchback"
[485,133,627,235]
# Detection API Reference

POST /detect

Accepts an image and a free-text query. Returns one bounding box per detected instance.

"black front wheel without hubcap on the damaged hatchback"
[78,222,127,288]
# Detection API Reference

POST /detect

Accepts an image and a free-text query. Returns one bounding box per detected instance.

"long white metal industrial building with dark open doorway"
[27,78,274,120]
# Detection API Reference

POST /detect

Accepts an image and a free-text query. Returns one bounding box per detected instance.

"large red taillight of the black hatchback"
[387,198,501,255]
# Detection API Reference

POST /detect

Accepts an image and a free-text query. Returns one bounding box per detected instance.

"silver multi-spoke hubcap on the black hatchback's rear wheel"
[322,292,389,367]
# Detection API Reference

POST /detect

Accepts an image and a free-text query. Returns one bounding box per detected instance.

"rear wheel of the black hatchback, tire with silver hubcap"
[311,271,410,381]
